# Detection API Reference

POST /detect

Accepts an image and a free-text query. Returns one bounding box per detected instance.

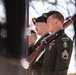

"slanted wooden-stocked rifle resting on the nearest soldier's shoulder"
[26,14,76,68]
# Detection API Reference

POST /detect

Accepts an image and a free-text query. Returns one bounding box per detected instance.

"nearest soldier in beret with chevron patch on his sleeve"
[41,11,73,75]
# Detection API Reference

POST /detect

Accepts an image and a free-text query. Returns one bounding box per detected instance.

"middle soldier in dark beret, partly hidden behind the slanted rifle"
[22,16,49,75]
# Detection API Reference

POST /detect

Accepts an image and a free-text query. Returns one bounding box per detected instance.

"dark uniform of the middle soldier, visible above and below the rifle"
[29,33,49,75]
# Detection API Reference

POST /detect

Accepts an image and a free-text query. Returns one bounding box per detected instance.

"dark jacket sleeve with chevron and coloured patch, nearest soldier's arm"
[53,37,73,75]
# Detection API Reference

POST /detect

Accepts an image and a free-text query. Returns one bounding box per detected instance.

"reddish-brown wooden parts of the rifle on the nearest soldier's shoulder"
[26,17,74,68]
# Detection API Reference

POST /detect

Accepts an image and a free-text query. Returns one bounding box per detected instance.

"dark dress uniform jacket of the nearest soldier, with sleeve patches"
[42,30,73,75]
